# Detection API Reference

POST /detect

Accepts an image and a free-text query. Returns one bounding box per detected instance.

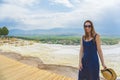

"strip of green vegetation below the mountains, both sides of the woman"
[12,35,120,45]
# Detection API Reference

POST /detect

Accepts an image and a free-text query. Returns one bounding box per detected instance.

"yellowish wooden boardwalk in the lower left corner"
[0,55,75,80]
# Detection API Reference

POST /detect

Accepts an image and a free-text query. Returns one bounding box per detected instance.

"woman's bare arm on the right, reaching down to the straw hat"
[96,34,106,68]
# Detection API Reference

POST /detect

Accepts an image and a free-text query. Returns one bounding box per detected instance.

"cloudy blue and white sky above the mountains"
[0,0,120,34]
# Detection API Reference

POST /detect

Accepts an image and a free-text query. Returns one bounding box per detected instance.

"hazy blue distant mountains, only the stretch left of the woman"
[9,28,83,36]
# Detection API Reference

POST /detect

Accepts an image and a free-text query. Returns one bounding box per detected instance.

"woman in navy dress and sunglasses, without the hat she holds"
[78,20,106,80]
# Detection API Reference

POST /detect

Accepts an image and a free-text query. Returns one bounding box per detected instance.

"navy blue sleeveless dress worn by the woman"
[78,34,100,80]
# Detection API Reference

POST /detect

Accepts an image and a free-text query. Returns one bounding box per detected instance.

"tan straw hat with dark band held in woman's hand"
[101,68,117,80]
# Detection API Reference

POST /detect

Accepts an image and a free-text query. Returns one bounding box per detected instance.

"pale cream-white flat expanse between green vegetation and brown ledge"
[0,43,120,76]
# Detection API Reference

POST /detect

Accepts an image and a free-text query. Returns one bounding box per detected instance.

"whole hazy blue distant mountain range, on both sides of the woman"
[9,28,120,37]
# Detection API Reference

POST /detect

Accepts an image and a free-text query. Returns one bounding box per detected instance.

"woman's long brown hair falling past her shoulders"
[84,20,96,39]
